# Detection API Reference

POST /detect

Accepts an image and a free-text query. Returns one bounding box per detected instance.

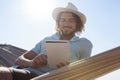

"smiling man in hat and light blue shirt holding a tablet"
[0,3,92,80]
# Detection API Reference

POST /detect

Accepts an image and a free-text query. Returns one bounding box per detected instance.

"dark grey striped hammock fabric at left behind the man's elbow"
[0,44,27,67]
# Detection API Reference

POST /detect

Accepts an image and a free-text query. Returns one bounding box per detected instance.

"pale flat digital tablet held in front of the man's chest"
[46,40,70,68]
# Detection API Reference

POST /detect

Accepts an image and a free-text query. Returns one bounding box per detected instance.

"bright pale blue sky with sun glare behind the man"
[0,0,120,80]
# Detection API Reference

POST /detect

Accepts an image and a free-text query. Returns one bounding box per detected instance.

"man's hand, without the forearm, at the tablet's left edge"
[31,54,47,68]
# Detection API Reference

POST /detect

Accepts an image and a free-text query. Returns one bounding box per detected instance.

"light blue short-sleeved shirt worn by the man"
[25,33,93,75]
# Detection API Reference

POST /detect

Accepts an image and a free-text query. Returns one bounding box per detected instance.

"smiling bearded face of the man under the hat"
[58,13,76,35]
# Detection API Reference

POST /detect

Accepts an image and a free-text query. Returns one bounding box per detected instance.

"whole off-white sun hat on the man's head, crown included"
[52,2,86,24]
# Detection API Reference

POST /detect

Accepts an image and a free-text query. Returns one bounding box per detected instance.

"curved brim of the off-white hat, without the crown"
[52,8,86,24]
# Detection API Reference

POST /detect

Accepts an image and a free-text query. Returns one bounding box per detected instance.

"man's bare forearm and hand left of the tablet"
[15,50,47,68]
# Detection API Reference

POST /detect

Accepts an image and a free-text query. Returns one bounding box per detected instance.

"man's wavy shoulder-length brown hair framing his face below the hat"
[55,12,84,33]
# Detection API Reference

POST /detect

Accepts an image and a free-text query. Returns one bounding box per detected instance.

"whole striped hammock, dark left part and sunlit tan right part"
[0,44,120,80]
